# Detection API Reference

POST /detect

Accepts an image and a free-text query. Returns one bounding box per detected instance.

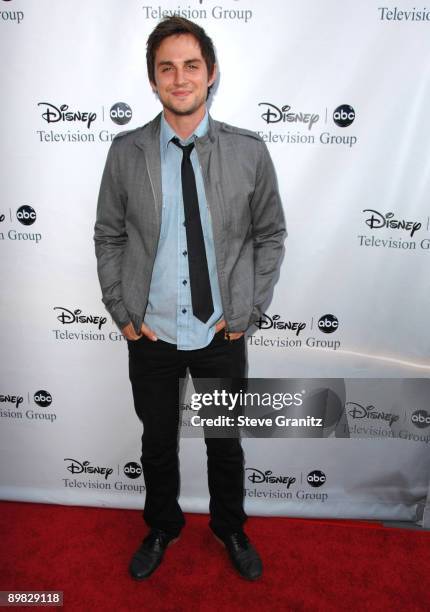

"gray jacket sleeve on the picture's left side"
[94,140,130,329]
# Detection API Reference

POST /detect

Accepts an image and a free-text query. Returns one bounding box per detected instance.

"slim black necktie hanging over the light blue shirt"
[172,137,214,323]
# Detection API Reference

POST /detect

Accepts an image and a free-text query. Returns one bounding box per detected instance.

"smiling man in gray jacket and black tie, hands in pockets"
[94,16,285,580]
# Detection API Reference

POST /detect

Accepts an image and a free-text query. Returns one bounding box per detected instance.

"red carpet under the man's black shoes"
[0,502,430,612]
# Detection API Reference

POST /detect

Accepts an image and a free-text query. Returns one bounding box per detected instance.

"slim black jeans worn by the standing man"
[128,330,247,537]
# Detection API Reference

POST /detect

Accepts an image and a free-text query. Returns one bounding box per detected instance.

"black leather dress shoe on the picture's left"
[129,529,179,580]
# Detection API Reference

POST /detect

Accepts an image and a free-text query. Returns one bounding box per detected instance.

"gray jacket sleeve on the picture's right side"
[248,141,287,327]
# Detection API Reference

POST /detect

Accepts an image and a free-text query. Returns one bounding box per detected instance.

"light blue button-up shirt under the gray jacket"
[144,111,223,350]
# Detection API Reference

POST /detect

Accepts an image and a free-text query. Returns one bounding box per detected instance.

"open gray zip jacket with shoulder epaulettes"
[94,115,286,331]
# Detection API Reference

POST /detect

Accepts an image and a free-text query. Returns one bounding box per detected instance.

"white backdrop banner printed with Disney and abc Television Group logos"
[0,0,430,526]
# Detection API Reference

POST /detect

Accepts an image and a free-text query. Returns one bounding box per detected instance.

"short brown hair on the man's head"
[146,15,216,90]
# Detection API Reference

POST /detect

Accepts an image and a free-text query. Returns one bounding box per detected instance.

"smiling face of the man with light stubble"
[151,34,216,115]
